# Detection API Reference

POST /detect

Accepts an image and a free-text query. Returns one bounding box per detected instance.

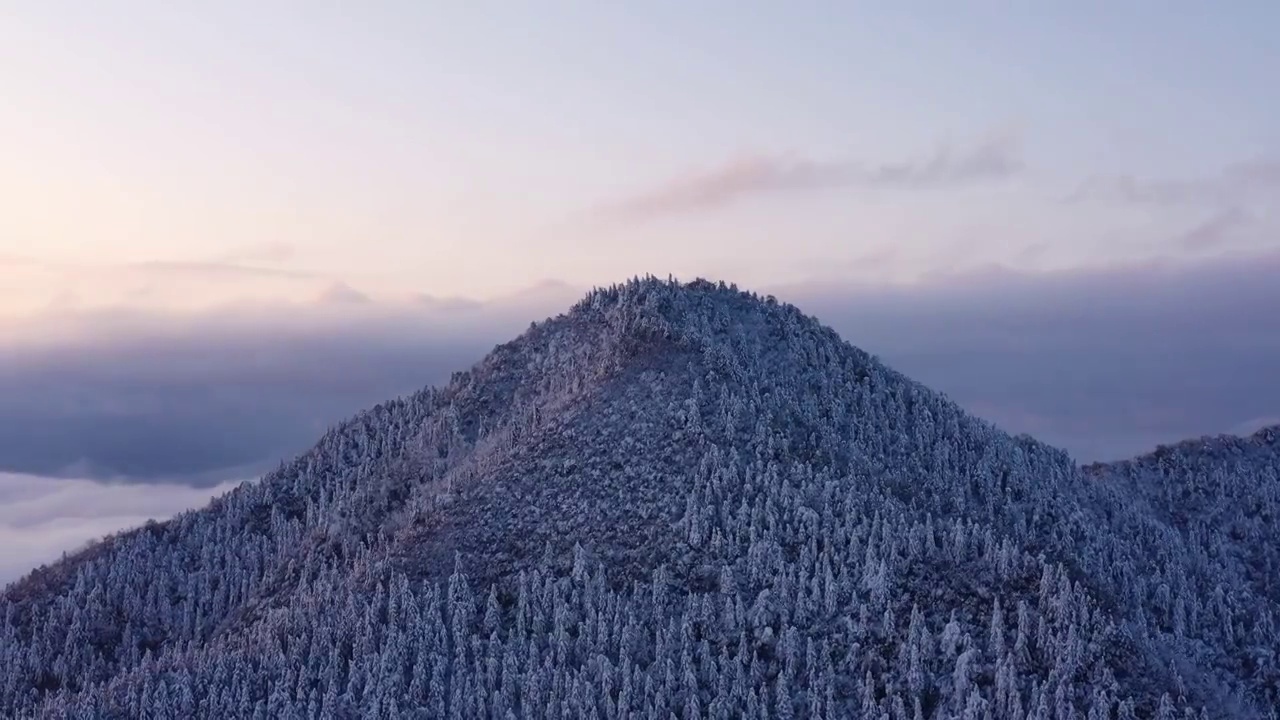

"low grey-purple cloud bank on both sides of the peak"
[0,255,1280,580]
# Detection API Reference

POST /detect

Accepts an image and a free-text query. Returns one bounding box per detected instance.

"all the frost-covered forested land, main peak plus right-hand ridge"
[0,279,1280,720]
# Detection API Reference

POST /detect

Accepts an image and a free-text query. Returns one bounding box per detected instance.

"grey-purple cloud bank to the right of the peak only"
[788,254,1280,461]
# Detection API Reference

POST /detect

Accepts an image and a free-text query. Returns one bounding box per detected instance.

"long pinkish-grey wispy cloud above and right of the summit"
[602,135,1024,220]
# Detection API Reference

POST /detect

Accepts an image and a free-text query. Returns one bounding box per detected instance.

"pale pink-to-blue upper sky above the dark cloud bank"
[0,0,1280,318]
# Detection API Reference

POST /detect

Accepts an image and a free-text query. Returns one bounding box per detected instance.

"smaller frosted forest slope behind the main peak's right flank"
[1085,425,1280,707]
